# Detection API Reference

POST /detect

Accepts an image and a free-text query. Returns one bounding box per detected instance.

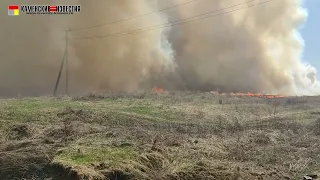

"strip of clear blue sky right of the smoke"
[300,0,320,79]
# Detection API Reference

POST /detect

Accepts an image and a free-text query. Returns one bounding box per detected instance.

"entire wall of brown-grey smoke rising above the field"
[0,0,320,96]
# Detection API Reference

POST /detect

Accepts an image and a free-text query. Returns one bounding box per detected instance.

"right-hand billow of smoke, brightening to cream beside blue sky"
[165,0,320,95]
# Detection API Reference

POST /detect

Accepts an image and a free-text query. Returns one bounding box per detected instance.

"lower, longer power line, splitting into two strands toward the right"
[75,0,274,39]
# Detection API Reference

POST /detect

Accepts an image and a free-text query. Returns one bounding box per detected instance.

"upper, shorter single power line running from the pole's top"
[71,0,202,31]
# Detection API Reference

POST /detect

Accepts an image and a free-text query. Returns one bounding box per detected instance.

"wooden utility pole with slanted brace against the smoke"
[53,29,70,96]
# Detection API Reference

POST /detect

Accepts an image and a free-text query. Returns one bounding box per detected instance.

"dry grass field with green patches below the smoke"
[0,92,320,180]
